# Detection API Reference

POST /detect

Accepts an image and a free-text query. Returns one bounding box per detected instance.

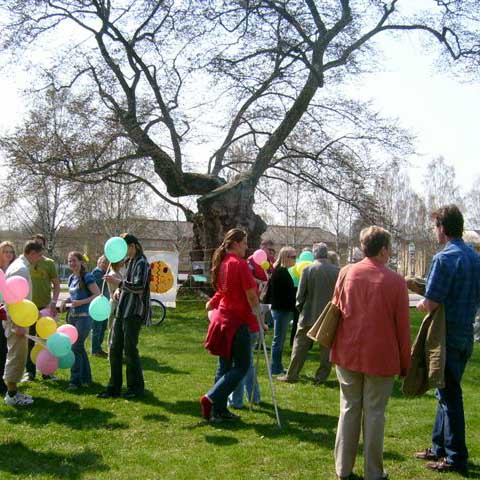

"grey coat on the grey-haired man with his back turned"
[297,258,340,327]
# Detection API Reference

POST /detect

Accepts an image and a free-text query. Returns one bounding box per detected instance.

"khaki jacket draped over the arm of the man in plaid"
[402,305,446,396]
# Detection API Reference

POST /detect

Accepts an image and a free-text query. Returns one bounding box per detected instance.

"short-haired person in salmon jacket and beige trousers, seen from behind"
[330,226,410,480]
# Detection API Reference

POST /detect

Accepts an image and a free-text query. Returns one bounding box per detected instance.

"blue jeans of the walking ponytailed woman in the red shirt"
[207,325,251,413]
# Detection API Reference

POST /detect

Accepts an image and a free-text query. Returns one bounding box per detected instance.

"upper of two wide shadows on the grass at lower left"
[0,397,128,430]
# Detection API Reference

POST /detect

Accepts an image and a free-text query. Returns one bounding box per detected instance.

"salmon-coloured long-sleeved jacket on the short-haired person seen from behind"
[330,257,410,377]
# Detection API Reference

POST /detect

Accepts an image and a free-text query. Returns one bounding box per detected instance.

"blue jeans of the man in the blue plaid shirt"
[432,341,473,467]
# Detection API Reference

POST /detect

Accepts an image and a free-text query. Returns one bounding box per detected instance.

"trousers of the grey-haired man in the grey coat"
[287,326,332,383]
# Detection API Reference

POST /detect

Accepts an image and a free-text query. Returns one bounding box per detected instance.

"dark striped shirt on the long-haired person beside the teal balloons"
[117,255,150,322]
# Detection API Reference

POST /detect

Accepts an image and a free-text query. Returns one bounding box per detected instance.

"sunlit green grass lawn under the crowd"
[0,298,480,480]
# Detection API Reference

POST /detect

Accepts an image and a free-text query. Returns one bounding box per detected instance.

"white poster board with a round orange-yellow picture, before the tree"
[147,251,178,308]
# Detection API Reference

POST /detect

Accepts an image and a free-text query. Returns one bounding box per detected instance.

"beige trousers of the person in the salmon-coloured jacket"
[335,366,393,480]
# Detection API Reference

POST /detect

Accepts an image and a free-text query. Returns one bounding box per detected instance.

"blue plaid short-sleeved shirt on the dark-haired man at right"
[425,239,480,347]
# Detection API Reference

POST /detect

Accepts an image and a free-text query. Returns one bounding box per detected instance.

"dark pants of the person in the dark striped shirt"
[107,316,145,395]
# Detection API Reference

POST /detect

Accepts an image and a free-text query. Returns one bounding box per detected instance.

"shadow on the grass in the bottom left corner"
[0,442,110,480]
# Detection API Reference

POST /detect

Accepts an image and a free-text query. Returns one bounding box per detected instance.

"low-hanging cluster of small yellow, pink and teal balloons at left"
[34,320,78,375]
